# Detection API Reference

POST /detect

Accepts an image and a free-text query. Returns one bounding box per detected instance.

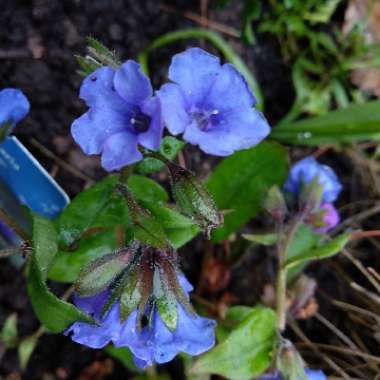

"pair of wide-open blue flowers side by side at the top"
[71,48,270,171]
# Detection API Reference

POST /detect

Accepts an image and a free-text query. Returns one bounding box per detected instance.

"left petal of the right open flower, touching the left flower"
[157,83,191,135]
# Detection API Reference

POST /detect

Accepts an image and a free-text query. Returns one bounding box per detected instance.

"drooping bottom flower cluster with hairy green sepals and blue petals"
[66,243,215,368]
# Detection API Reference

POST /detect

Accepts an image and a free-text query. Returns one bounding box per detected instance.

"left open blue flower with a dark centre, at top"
[71,60,163,171]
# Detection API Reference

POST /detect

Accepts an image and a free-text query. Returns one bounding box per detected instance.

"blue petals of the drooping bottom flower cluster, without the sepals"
[66,273,215,368]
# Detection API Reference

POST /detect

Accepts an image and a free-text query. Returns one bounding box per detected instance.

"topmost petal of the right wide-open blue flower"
[169,48,221,106]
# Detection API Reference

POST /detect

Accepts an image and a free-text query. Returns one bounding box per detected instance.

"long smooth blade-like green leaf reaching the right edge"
[270,100,380,146]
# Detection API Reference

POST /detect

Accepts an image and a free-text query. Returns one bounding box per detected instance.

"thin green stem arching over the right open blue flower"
[138,28,264,110]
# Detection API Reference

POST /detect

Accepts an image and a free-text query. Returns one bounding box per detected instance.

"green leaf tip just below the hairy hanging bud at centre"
[144,203,200,248]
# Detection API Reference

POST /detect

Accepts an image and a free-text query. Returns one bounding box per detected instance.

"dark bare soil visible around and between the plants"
[0,0,379,380]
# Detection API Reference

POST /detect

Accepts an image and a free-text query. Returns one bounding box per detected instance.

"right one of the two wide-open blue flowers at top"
[157,48,270,156]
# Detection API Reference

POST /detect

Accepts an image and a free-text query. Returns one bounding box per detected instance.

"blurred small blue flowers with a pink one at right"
[284,157,342,233]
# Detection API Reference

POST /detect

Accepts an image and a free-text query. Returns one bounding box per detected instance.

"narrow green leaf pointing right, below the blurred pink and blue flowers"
[285,233,351,268]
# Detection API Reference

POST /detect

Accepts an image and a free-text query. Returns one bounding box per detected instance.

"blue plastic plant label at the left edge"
[0,136,69,218]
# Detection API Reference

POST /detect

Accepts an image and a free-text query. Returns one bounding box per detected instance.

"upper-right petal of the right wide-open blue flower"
[201,63,256,112]
